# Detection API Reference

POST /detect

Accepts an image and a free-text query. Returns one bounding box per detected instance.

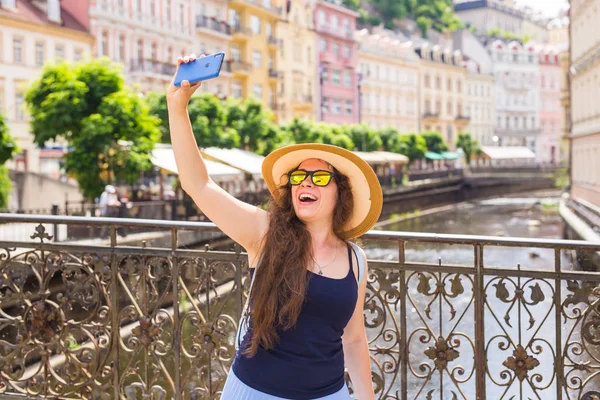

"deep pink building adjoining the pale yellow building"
[315,0,360,124]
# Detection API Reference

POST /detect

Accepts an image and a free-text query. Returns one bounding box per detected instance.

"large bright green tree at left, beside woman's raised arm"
[26,58,161,199]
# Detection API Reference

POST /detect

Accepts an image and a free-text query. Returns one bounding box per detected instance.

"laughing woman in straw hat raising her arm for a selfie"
[167,55,382,400]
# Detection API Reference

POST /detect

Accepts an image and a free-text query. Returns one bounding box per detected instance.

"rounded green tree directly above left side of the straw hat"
[225,99,282,155]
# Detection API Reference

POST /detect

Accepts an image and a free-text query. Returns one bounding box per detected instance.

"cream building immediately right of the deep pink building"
[355,29,419,133]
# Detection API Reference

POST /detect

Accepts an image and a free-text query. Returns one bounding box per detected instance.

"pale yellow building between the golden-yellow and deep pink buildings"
[276,0,316,122]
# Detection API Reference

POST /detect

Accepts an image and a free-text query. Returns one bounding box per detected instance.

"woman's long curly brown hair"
[242,164,354,357]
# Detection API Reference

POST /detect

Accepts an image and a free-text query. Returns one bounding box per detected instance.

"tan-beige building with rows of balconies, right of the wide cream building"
[417,43,470,148]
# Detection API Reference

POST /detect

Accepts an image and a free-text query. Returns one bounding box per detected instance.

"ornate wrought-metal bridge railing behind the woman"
[0,214,600,400]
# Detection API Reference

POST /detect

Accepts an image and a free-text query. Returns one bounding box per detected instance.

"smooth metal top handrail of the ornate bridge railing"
[0,213,600,251]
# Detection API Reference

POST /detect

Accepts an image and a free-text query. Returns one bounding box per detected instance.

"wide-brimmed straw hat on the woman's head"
[262,143,383,239]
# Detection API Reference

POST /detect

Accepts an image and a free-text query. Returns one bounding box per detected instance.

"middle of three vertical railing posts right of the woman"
[473,244,487,400]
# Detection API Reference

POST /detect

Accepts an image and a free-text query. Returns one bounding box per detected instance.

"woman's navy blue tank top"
[232,247,358,400]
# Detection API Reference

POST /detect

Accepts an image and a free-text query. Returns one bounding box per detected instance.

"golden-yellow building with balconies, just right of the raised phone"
[229,0,283,109]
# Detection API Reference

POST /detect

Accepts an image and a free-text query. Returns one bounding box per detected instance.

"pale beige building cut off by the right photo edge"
[570,0,600,207]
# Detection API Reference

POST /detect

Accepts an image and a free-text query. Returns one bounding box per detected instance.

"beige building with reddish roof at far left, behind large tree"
[0,0,94,176]
